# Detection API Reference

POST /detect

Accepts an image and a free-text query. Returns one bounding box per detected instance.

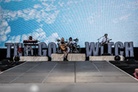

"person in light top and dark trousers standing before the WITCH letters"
[101,34,112,54]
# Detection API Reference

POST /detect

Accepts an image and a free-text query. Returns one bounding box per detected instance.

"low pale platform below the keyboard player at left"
[20,56,48,61]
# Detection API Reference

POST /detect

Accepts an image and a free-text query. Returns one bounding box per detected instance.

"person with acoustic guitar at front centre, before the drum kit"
[60,37,68,61]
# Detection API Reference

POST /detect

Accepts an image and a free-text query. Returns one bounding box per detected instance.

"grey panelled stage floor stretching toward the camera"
[0,61,138,92]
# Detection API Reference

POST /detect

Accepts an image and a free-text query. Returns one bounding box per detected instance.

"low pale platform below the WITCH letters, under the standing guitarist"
[89,56,124,61]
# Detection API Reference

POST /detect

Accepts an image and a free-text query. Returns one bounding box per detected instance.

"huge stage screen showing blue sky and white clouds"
[0,0,138,48]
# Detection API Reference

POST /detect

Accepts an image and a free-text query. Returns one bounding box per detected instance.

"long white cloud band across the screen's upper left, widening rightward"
[0,2,59,24]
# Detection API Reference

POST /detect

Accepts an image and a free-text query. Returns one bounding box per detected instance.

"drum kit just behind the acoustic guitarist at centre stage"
[57,38,80,53]
